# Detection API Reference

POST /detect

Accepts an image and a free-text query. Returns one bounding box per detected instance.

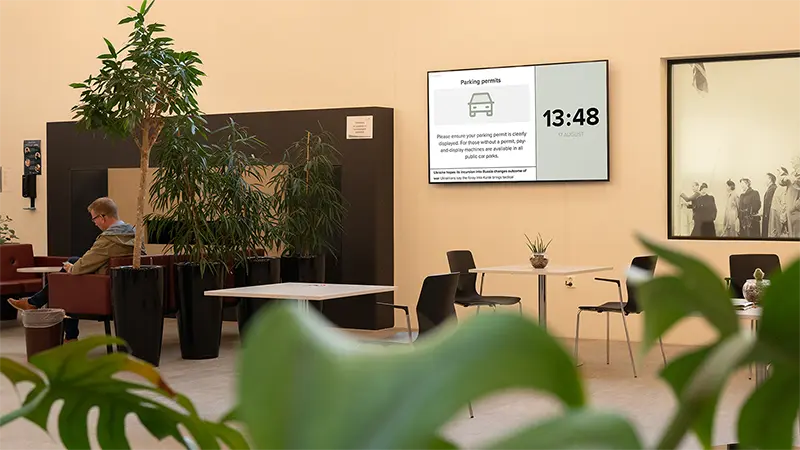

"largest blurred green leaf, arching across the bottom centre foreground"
[239,306,585,450]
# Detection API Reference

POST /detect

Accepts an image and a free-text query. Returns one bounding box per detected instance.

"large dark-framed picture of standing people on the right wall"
[667,54,800,240]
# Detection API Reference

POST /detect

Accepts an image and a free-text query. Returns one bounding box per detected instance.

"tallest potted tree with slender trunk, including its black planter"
[71,0,204,362]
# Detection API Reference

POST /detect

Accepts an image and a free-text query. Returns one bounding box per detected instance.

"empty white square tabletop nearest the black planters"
[204,283,396,312]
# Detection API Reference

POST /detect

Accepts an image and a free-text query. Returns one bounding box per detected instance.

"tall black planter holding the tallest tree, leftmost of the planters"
[111,266,164,366]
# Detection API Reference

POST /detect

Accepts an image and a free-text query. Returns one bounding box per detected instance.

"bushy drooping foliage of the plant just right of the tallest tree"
[147,119,273,270]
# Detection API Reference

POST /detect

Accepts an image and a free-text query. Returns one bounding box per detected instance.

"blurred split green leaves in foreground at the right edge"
[639,240,800,450]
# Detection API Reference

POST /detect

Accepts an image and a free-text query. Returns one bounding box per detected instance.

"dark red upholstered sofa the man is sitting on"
[49,255,178,335]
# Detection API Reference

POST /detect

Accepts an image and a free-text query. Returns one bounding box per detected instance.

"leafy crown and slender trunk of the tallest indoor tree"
[70,0,205,268]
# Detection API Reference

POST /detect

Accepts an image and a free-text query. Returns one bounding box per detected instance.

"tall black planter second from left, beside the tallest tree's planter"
[175,263,222,359]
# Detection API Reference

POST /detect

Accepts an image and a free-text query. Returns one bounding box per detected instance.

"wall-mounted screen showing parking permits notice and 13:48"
[428,61,609,184]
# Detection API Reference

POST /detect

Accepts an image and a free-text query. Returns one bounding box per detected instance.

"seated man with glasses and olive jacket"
[8,197,144,341]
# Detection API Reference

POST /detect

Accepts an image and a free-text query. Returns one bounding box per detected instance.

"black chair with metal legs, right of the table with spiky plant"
[575,255,667,378]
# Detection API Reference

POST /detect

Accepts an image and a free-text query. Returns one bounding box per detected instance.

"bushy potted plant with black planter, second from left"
[147,120,280,359]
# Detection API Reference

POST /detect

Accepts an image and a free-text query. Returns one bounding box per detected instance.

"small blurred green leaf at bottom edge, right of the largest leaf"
[488,410,642,450]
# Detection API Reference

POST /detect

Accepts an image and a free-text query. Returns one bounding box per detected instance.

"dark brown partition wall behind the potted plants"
[47,107,394,329]
